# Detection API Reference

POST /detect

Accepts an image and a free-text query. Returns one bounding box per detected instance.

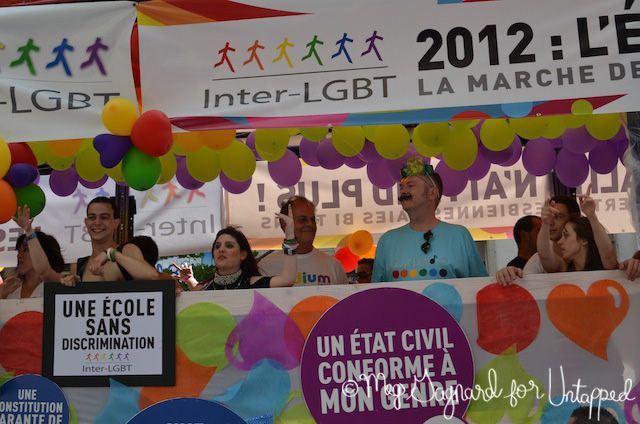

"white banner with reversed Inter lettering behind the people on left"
[0,177,222,266]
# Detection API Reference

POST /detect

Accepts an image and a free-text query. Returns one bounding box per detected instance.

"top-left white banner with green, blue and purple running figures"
[0,1,136,141]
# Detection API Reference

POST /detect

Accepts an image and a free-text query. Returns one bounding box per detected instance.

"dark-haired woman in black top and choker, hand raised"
[176,209,297,290]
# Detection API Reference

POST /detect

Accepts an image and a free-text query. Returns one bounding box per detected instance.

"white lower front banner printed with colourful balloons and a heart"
[0,271,640,424]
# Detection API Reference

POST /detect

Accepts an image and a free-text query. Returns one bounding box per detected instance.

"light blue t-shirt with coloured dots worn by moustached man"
[372,222,489,282]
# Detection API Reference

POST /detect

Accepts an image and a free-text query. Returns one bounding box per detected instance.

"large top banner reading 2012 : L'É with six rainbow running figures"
[138,0,640,129]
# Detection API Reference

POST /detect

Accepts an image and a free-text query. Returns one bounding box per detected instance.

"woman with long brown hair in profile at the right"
[539,217,605,272]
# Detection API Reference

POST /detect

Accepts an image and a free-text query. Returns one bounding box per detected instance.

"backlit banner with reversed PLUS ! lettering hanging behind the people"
[227,160,635,248]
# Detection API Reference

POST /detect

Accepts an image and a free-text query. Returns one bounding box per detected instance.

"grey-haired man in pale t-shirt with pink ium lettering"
[258,196,348,286]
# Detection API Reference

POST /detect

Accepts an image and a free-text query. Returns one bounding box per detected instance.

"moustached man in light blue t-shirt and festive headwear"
[373,157,488,282]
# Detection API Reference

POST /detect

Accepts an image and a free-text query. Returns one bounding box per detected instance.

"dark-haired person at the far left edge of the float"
[0,230,64,299]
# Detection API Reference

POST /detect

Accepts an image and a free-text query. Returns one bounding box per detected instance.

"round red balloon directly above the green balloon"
[131,110,173,157]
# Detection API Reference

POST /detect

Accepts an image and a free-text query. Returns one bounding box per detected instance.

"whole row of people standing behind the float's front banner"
[0,157,640,299]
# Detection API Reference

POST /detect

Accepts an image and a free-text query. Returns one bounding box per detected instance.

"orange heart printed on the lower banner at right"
[547,280,629,361]
